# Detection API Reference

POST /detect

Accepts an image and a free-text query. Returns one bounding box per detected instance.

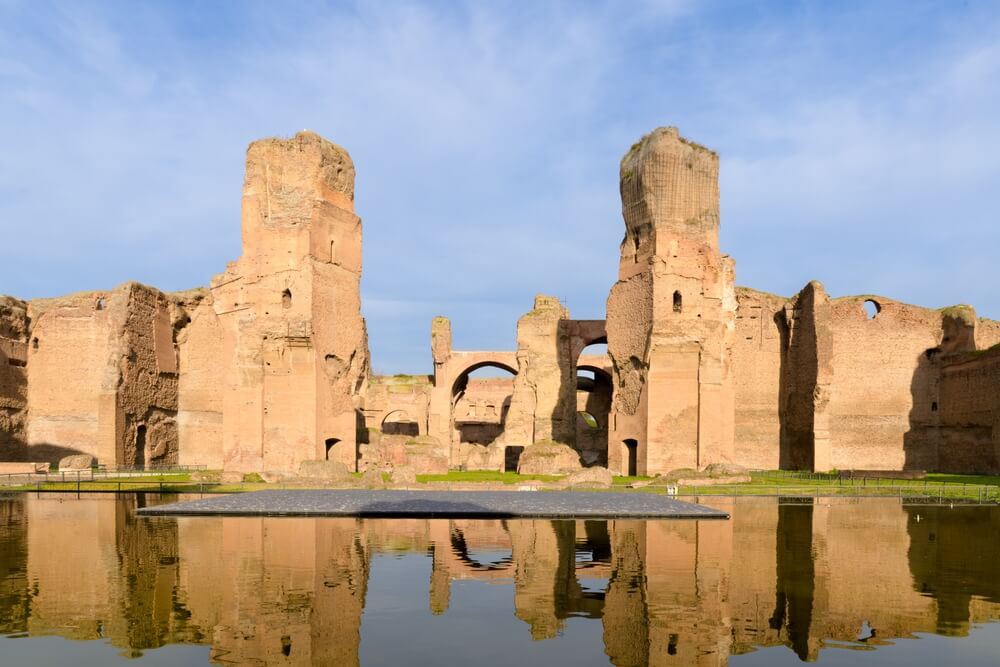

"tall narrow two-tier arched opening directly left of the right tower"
[576,337,612,467]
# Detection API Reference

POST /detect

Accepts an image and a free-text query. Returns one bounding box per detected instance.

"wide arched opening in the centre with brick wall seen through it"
[452,361,517,452]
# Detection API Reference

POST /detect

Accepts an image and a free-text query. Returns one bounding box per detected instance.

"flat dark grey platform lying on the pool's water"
[139,489,729,519]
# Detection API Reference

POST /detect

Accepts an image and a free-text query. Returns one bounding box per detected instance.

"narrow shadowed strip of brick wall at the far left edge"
[0,296,28,461]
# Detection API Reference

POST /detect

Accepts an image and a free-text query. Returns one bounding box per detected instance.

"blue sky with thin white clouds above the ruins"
[0,0,1000,373]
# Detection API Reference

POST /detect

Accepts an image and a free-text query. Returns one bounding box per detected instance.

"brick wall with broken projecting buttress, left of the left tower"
[25,283,178,465]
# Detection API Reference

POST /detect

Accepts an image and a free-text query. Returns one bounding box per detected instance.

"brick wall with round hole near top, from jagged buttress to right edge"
[779,290,997,471]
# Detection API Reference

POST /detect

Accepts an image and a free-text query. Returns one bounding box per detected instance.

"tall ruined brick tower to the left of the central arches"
[212,132,368,470]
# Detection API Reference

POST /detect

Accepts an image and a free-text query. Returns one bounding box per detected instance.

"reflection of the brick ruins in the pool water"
[0,496,1000,665]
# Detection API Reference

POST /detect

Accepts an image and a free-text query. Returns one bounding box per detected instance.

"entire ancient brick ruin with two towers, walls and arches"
[0,128,1000,475]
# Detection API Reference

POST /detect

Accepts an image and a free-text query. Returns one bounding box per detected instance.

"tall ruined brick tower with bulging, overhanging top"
[607,127,735,475]
